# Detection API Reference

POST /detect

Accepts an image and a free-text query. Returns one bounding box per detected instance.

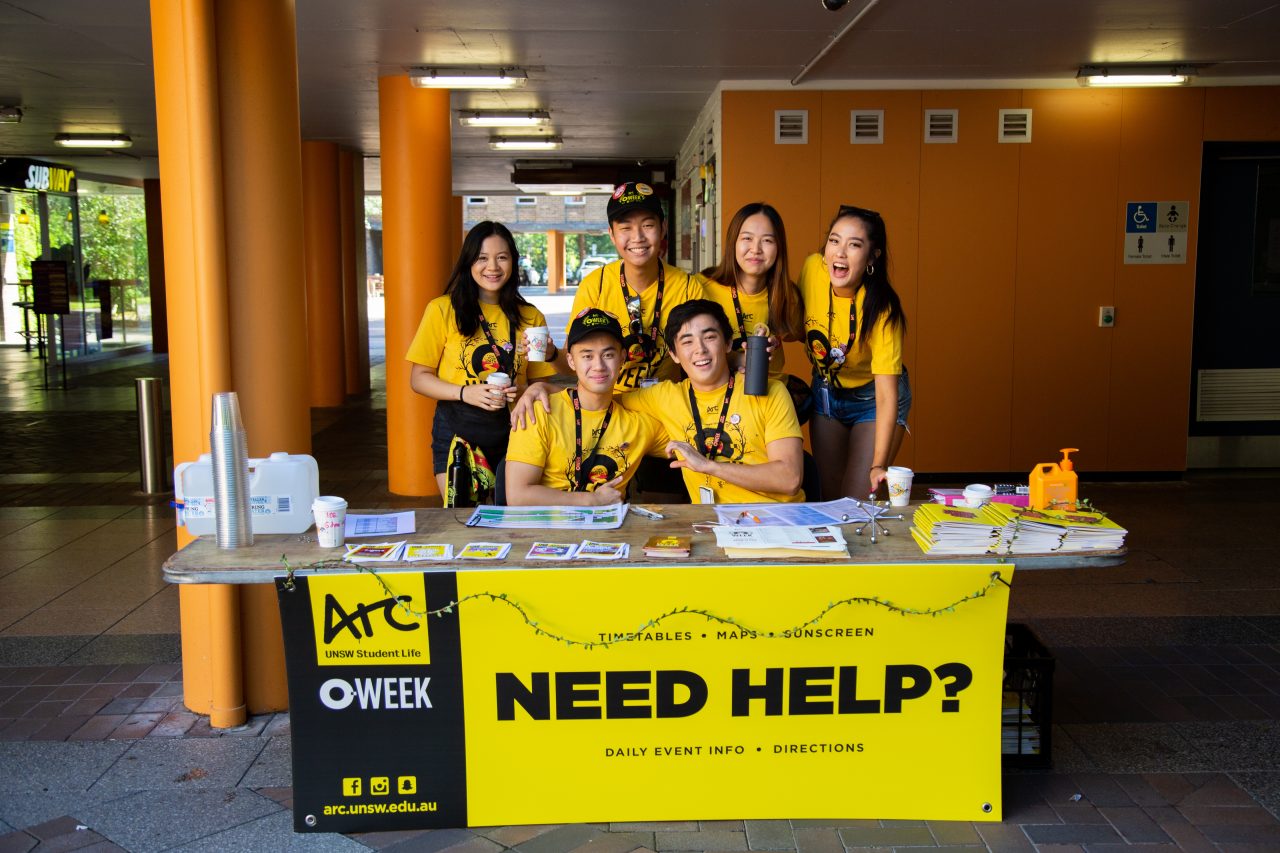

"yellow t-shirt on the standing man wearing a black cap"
[570,261,705,392]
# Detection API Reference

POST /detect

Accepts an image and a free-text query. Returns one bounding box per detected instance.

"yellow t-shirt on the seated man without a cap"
[616,379,804,503]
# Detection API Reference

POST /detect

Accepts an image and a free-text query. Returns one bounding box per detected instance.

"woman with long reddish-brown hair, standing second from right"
[703,201,804,379]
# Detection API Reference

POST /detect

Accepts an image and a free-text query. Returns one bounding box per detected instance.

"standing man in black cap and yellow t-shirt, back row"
[573,182,704,392]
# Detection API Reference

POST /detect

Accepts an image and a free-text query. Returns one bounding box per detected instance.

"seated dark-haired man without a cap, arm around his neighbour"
[512,300,804,503]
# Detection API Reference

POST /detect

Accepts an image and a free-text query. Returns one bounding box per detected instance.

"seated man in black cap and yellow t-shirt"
[506,309,667,506]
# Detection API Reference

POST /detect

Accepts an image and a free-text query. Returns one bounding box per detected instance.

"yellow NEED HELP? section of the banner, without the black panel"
[458,564,1012,826]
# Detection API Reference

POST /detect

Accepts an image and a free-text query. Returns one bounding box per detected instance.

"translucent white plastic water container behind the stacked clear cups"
[173,453,320,535]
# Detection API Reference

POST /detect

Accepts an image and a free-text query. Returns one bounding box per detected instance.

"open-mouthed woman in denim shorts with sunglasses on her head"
[800,205,911,498]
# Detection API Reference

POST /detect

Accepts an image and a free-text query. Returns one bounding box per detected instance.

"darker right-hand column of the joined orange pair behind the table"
[216,0,311,713]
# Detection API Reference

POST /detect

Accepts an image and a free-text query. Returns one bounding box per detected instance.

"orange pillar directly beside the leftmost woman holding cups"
[378,74,454,494]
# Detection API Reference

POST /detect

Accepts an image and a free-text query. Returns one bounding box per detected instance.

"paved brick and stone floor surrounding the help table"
[0,306,1280,853]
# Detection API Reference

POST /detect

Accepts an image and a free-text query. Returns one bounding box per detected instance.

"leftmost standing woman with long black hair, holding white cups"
[404,222,556,494]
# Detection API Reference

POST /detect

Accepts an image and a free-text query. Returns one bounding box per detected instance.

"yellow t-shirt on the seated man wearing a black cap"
[507,391,667,492]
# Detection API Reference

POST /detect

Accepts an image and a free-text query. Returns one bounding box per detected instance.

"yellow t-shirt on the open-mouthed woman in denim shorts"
[800,254,902,388]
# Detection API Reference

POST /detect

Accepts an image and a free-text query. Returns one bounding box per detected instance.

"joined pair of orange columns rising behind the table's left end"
[151,0,311,727]
